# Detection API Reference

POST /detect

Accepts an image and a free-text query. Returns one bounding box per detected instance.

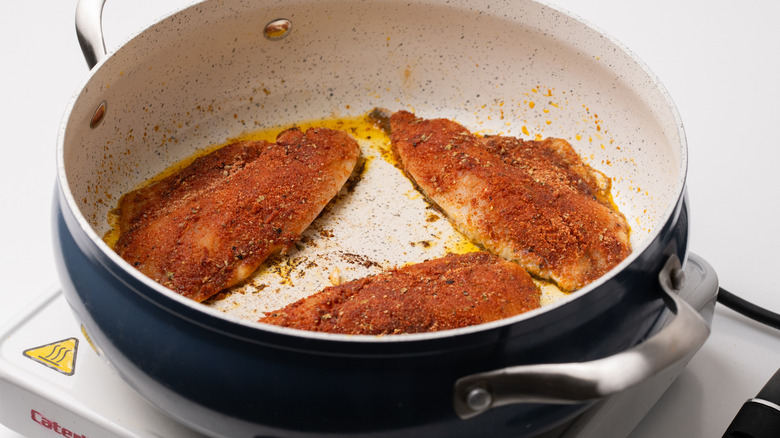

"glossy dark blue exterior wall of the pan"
[54,182,688,437]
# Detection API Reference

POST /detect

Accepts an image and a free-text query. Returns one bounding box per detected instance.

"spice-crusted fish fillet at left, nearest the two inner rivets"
[114,128,360,301]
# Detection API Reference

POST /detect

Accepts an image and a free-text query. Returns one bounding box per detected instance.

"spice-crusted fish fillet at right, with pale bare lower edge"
[390,111,631,291]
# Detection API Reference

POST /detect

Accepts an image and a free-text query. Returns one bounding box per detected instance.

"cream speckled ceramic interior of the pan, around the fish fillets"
[59,0,687,320]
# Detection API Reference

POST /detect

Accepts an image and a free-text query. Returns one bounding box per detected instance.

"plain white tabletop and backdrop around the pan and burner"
[0,0,780,438]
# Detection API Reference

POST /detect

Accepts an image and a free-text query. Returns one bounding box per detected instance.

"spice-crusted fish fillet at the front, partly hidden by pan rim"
[260,252,540,335]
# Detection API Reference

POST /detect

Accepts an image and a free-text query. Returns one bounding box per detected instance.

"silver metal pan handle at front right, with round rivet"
[454,255,710,419]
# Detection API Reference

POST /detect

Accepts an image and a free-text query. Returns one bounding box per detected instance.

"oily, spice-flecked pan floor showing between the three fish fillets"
[105,116,566,321]
